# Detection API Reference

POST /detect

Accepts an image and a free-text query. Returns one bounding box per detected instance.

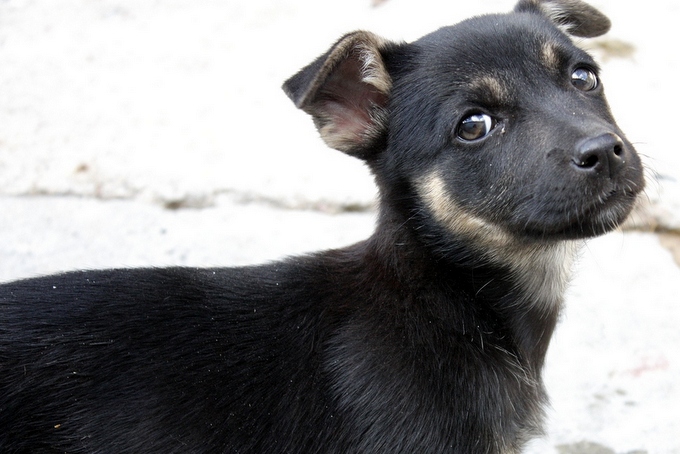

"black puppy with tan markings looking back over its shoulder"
[0,0,643,454]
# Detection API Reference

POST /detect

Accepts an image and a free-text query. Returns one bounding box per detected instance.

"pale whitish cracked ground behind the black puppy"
[0,0,680,454]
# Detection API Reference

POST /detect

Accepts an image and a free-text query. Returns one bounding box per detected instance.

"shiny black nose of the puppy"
[573,133,626,177]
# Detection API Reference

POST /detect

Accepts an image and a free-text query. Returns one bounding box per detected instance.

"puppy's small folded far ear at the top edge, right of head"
[515,0,611,38]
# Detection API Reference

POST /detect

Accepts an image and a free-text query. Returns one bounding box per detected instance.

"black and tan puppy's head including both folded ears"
[284,0,644,260]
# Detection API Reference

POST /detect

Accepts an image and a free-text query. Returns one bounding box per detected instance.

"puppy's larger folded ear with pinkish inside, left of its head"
[283,31,392,159]
